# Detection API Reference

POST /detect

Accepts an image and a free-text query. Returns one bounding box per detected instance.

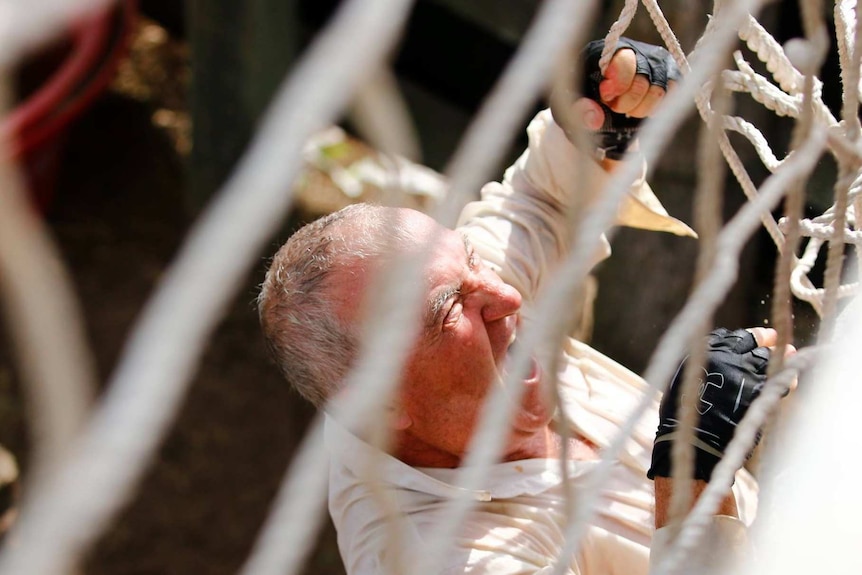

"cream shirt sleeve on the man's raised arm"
[459,110,694,302]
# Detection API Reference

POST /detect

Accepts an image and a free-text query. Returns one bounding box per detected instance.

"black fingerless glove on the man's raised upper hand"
[552,38,681,160]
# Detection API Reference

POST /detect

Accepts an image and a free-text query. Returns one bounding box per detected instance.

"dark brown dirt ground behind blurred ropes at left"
[0,15,343,575]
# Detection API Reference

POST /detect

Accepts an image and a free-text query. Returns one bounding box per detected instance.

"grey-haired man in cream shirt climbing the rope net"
[259,41,775,574]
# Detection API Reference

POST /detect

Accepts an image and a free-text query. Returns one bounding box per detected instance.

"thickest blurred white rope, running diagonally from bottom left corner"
[0,0,418,575]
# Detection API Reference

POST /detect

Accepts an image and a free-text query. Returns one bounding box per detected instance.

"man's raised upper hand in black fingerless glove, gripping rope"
[552,38,680,160]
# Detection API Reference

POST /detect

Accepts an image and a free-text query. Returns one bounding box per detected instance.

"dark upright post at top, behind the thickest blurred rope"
[186,0,299,210]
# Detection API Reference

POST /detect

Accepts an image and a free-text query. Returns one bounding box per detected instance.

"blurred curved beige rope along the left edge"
[0,91,96,486]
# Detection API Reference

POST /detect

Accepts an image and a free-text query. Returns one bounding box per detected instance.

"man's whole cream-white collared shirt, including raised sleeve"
[326,111,757,575]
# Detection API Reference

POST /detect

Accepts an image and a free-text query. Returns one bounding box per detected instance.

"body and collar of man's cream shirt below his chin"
[325,341,757,575]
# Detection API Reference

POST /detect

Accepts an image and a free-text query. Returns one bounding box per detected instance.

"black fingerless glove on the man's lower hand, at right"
[647,328,769,481]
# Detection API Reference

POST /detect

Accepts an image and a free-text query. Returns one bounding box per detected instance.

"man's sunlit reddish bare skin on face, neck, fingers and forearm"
[333,48,793,527]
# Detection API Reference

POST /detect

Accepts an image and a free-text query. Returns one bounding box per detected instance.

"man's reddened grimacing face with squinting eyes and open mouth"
[334,211,550,465]
